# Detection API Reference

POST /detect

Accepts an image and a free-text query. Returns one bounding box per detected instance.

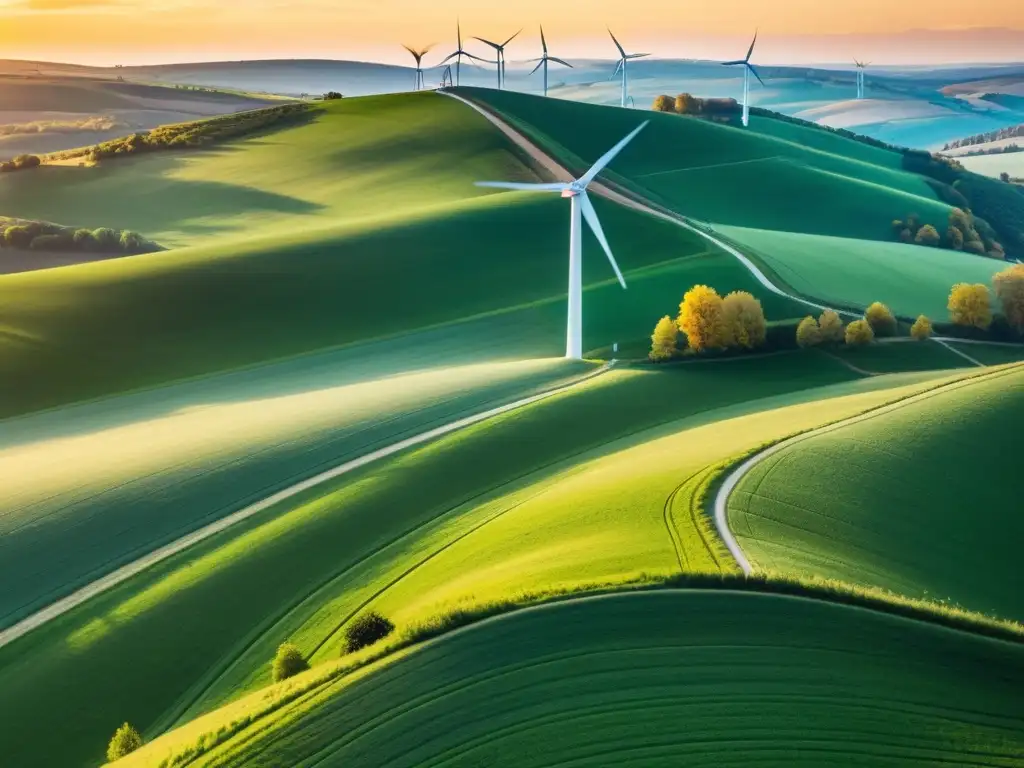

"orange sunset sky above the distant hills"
[8,0,1024,65]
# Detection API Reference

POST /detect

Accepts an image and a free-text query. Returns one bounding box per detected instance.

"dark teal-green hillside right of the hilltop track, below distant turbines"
[460,88,949,240]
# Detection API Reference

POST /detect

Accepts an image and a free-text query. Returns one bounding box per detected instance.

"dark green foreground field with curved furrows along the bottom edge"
[117,591,1024,768]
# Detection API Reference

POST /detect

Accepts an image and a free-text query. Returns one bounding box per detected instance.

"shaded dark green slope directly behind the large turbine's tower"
[0,195,798,417]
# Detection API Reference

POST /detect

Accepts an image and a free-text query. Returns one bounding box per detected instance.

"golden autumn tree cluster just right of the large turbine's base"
[648,286,768,362]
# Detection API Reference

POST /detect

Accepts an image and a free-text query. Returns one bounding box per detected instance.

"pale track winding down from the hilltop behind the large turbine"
[439,91,843,316]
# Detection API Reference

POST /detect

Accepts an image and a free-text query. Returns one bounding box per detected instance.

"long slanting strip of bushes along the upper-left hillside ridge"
[52,103,312,163]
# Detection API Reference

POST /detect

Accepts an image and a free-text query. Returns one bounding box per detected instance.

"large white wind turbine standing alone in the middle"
[476,122,647,359]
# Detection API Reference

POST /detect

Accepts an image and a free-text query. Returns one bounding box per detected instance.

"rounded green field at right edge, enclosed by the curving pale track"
[729,366,1024,621]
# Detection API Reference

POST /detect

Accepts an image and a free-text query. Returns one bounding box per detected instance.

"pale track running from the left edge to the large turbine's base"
[0,360,615,648]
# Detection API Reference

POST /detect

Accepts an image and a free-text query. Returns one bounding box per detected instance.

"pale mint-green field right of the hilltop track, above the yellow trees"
[716,226,1006,321]
